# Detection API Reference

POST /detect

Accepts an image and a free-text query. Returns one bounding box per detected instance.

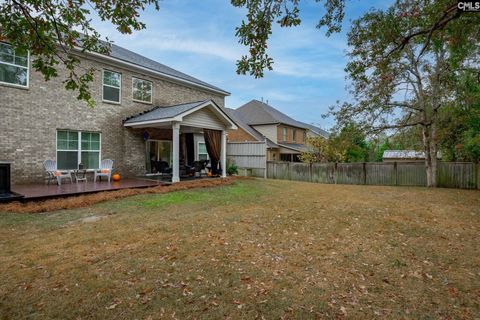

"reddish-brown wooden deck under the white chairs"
[12,179,167,201]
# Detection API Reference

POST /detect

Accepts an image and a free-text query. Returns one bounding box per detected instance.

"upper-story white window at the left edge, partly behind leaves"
[0,42,29,88]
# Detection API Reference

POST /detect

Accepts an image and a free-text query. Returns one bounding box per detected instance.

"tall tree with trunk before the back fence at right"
[331,0,480,186]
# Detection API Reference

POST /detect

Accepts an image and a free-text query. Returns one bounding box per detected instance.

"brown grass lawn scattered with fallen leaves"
[0,180,480,319]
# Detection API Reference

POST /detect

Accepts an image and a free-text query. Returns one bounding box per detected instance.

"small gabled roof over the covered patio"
[123,100,236,128]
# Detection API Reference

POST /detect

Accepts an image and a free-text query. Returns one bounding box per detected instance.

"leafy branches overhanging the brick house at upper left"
[0,0,159,106]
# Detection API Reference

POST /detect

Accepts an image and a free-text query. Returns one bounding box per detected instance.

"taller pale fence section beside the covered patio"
[227,141,267,178]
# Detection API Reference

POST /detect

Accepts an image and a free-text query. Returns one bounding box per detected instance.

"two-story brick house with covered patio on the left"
[0,42,236,184]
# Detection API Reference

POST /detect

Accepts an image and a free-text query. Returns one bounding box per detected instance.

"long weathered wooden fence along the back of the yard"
[267,161,480,189]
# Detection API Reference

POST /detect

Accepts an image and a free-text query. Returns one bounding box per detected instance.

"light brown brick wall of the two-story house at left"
[0,52,224,184]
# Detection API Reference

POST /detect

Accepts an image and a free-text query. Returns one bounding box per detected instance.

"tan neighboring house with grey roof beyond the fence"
[226,100,328,161]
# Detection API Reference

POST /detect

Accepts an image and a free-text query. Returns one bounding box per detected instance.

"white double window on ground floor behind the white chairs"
[57,130,101,169]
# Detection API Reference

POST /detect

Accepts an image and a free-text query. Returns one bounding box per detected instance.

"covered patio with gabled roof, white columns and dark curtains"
[123,100,237,183]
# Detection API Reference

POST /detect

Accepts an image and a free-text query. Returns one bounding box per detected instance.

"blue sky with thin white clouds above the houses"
[94,0,390,129]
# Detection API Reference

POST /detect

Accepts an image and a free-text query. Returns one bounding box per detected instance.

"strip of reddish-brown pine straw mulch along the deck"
[0,177,245,213]
